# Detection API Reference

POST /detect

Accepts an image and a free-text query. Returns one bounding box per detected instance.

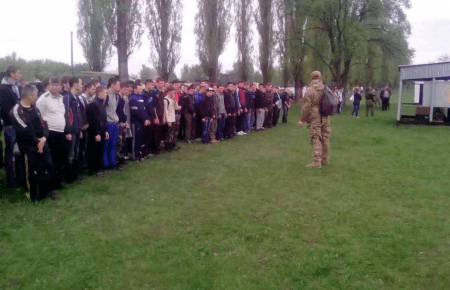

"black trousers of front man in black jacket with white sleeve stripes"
[25,148,53,201]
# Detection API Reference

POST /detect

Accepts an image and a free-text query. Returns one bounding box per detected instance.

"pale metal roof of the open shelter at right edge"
[398,62,450,80]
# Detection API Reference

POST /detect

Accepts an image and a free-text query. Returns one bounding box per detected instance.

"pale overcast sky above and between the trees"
[0,0,450,76]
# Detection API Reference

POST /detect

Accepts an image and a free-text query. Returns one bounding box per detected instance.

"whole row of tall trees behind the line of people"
[1,0,414,98]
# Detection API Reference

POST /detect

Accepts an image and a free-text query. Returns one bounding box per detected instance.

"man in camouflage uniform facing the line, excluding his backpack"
[298,71,331,168]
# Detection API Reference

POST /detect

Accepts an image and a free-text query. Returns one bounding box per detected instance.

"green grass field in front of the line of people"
[0,94,450,290]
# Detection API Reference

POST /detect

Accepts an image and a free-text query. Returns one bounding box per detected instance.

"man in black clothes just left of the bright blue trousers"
[86,87,109,175]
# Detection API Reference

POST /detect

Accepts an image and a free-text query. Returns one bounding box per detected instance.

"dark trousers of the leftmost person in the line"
[4,126,26,188]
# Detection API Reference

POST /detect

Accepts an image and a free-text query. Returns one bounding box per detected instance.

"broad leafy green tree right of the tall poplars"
[288,0,412,86]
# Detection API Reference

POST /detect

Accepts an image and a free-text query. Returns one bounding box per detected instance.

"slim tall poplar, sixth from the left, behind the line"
[255,0,275,83]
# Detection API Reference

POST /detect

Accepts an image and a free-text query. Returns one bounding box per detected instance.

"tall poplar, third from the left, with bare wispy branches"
[146,0,183,80]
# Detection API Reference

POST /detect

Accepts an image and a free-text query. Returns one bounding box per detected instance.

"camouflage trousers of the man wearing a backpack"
[309,116,331,163]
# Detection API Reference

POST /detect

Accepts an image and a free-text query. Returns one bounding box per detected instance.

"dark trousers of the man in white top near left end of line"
[47,131,69,187]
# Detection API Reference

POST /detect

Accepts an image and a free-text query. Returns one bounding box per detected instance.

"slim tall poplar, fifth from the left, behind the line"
[234,0,255,81]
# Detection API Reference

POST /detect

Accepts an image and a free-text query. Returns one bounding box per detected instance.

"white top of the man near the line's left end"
[36,92,66,133]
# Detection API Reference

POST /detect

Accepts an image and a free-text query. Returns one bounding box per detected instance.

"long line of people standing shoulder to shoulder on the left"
[0,66,290,201]
